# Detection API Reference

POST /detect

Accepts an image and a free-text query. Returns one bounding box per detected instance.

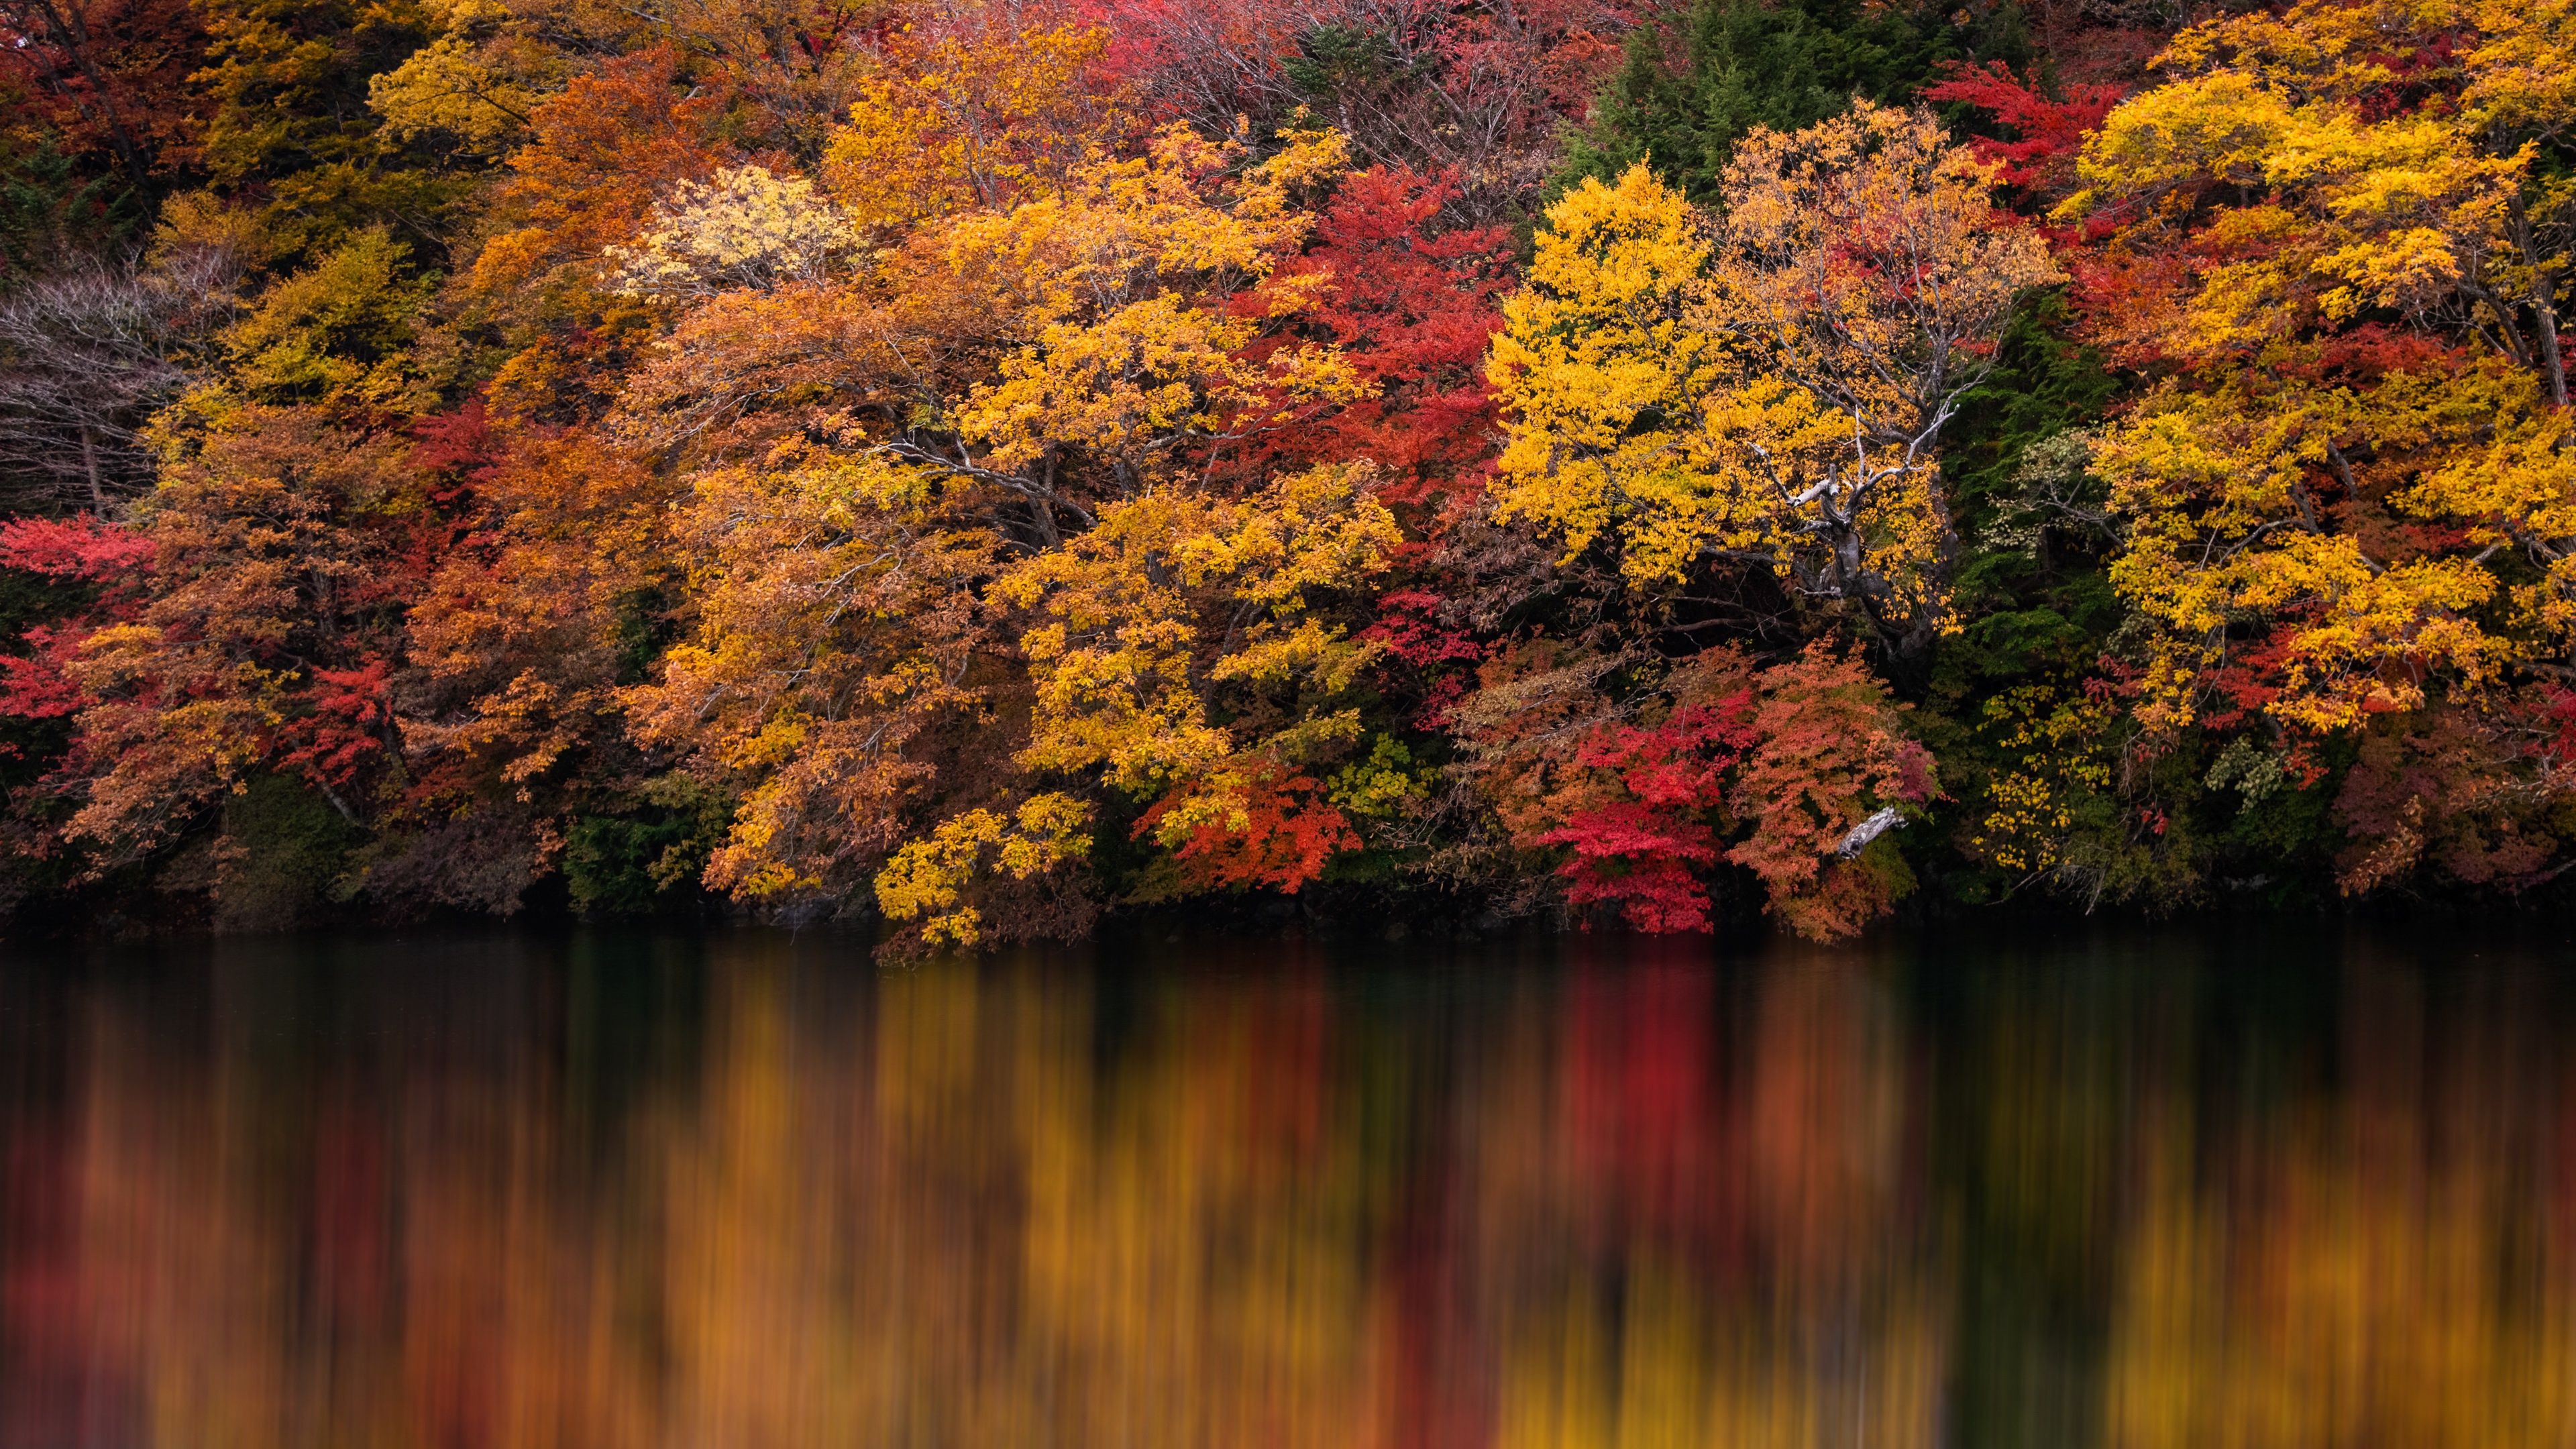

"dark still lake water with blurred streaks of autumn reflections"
[0,926,2576,1449]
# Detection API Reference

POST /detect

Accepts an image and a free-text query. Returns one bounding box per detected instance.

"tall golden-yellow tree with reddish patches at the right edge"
[2063,0,2576,890]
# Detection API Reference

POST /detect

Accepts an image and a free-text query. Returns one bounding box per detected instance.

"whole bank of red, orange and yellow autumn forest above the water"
[0,0,2576,938]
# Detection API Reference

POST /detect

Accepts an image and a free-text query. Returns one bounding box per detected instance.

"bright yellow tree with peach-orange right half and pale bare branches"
[1491,103,2058,652]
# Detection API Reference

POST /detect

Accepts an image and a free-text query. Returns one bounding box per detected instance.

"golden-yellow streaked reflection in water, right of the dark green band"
[2110,967,2576,1449]
